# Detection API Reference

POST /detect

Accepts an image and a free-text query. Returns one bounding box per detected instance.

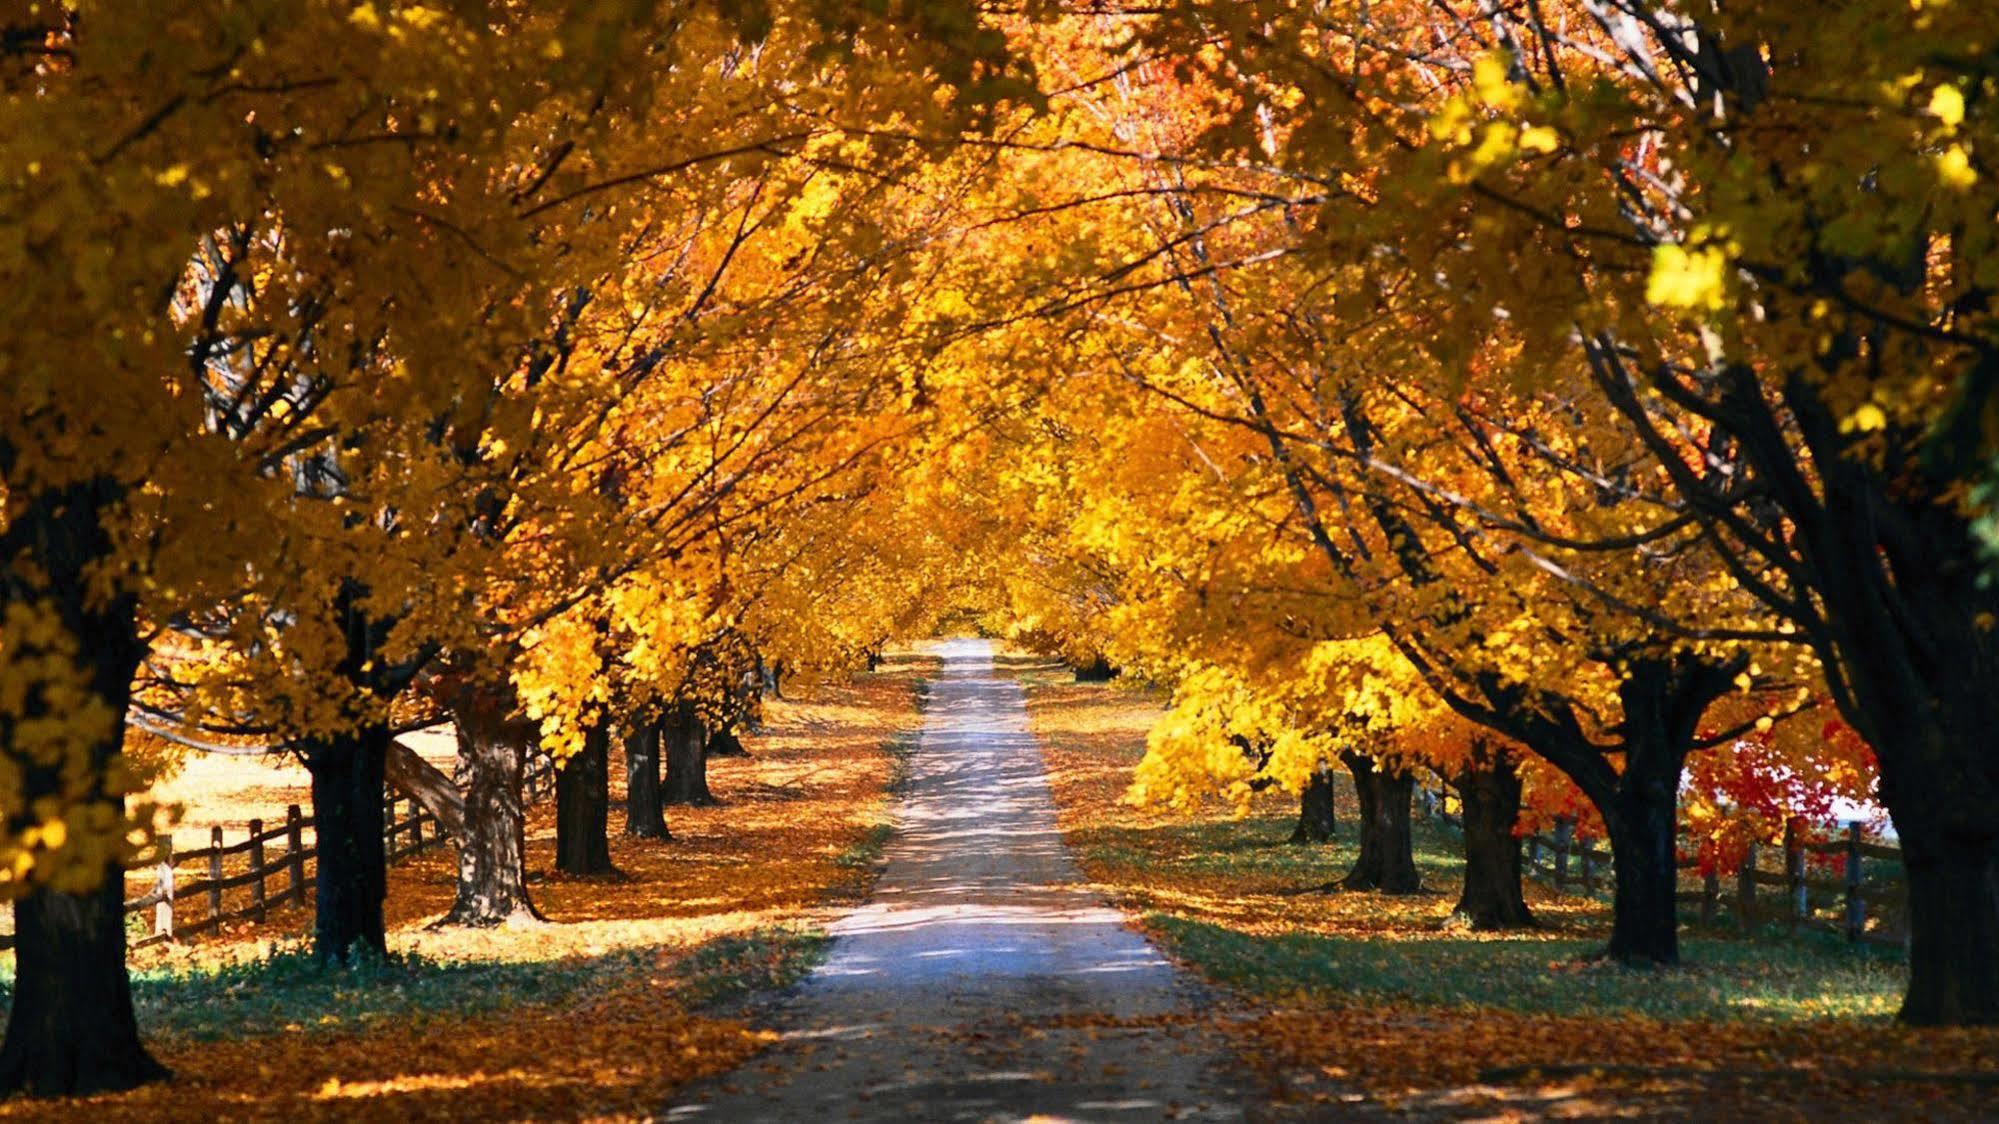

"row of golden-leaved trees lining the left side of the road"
[0,0,1029,1094]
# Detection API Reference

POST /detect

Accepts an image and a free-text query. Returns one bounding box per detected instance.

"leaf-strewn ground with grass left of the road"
[0,660,928,1122]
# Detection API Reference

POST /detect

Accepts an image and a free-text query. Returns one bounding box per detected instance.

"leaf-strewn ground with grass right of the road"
[1015,660,1999,1120]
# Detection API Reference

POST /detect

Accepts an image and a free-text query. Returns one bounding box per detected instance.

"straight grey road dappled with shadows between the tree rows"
[666,640,1245,1122]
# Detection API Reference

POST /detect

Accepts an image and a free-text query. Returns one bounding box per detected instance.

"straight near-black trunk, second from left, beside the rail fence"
[302,722,392,952]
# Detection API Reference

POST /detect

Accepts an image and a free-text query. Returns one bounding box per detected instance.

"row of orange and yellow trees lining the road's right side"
[931,0,1999,1024]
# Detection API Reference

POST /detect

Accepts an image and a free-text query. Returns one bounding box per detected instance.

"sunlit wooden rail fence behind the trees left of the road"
[101,754,556,948]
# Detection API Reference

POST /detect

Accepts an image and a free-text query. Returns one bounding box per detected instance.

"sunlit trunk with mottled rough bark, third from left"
[438,688,542,928]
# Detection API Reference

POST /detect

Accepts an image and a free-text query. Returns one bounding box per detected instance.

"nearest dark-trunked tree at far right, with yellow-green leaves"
[1143,0,1999,1022]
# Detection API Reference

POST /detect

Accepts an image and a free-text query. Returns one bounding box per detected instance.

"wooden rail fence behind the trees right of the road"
[1423,794,1909,946]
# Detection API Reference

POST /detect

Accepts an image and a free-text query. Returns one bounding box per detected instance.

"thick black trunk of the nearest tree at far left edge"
[0,468,168,1096]
